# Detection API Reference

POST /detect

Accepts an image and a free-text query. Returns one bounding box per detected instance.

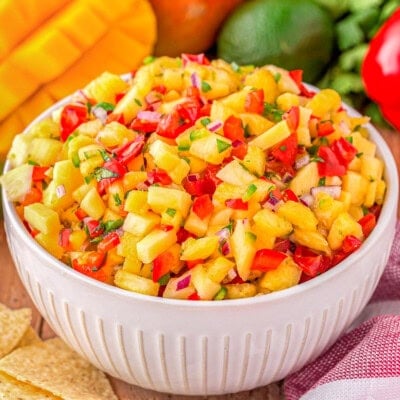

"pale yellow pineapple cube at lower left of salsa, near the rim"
[24,203,61,235]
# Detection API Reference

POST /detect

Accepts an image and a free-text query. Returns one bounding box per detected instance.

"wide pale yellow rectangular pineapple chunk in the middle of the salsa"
[147,186,192,217]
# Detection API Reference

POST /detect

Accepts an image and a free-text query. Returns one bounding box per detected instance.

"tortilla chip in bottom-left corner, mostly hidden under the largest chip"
[0,373,61,400]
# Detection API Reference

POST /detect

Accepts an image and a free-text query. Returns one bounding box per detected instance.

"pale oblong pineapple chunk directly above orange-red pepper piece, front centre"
[136,229,177,263]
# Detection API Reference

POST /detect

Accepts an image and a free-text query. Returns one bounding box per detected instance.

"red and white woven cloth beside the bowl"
[284,222,400,400]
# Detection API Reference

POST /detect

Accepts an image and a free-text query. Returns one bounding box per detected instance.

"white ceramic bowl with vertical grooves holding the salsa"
[3,95,398,395]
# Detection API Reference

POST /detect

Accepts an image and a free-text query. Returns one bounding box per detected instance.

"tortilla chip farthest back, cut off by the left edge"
[0,307,32,358]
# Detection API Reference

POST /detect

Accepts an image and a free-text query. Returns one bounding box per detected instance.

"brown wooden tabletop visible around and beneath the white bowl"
[0,130,400,400]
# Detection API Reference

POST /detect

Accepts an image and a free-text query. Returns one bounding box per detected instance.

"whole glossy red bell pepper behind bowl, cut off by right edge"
[361,8,400,130]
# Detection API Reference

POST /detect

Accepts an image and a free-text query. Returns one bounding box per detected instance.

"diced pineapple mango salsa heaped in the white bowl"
[1,54,386,300]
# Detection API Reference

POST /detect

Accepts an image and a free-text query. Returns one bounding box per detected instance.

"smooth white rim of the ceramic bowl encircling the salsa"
[1,89,399,309]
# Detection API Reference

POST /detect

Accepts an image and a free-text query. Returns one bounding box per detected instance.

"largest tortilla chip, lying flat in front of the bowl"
[0,338,117,400]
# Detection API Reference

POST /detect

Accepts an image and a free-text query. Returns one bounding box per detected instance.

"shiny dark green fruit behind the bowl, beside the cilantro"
[217,0,334,83]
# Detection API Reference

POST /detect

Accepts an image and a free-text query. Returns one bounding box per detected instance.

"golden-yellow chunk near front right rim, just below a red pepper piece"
[259,257,301,292]
